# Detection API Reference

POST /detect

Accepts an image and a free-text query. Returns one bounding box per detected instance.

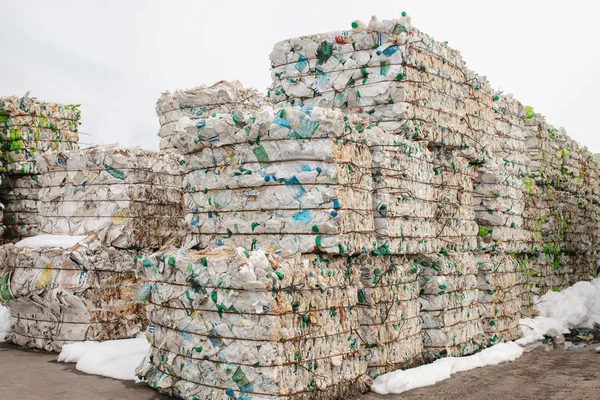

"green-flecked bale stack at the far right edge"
[524,111,600,304]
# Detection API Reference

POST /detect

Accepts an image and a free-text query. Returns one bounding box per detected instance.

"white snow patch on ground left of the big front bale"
[58,337,150,381]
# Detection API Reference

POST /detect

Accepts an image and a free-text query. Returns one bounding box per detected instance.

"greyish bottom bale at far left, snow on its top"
[0,236,146,351]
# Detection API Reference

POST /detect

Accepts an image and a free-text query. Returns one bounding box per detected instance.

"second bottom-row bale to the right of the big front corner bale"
[414,252,485,361]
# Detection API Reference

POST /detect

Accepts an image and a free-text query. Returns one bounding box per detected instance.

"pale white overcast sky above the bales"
[0,0,600,152]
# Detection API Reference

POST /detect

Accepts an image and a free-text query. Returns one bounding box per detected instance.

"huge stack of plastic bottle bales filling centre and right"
[138,13,600,398]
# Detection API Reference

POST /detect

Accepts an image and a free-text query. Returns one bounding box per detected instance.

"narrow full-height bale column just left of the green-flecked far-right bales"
[473,90,537,338]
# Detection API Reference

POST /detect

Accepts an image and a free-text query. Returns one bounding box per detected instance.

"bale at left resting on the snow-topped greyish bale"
[37,145,185,248]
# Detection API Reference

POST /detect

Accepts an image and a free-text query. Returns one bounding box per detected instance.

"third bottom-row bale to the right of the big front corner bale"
[477,253,528,344]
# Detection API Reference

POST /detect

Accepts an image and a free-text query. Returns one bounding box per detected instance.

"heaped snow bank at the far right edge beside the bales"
[516,278,600,345]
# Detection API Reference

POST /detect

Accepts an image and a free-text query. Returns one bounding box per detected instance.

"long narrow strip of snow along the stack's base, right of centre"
[371,342,523,394]
